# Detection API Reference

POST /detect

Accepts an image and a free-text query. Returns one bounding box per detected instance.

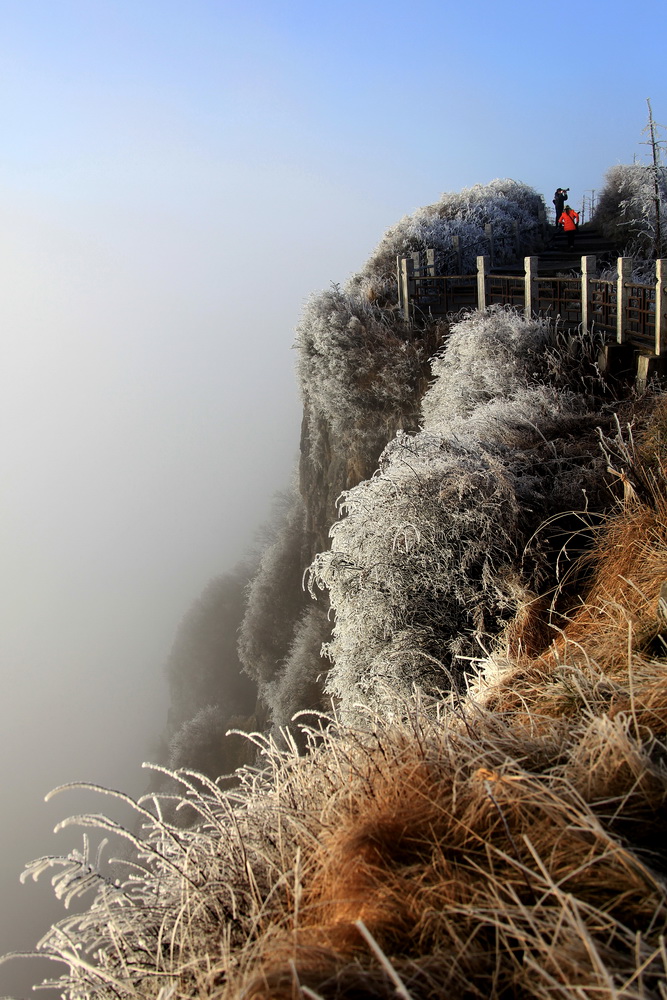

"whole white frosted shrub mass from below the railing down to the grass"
[311,310,620,718]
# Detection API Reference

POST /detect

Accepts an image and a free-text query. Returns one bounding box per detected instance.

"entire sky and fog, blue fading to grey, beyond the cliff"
[0,0,667,993]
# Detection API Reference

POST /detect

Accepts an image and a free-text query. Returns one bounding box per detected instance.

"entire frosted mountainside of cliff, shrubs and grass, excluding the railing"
[9,182,667,1000]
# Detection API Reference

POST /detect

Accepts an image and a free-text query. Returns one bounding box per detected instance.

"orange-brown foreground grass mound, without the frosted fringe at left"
[220,696,667,1000]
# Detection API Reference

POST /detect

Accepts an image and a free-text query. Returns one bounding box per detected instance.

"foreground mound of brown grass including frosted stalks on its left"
[9,640,667,1000]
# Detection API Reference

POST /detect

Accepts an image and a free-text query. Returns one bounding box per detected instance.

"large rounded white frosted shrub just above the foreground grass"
[313,434,519,719]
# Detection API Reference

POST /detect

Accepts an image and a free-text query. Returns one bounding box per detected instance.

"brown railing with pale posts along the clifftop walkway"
[397,251,667,356]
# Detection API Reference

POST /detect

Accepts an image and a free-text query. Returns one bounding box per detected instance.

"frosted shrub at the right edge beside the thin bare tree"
[594,163,667,257]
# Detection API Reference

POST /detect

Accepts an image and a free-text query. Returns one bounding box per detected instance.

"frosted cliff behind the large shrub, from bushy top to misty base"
[166,181,543,756]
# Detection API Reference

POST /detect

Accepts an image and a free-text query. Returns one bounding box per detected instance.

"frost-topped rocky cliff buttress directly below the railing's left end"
[297,294,438,565]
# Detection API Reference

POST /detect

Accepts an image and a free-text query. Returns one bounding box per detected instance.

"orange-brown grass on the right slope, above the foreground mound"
[485,401,667,734]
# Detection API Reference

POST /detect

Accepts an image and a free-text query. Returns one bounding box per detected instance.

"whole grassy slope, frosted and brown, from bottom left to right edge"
[10,368,667,1000]
